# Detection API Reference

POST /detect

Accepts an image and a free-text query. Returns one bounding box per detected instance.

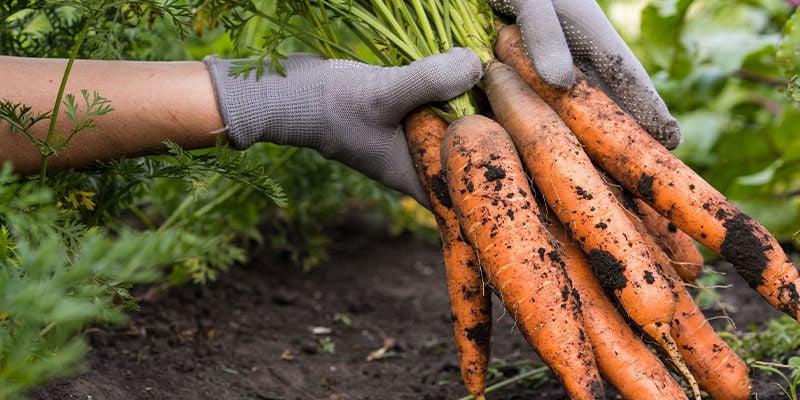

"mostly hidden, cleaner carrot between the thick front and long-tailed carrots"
[547,208,686,400]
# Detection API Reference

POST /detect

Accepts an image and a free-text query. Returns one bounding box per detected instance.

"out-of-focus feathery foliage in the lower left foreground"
[0,164,247,398]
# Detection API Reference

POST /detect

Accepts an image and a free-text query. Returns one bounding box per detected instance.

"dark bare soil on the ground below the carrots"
[29,221,787,400]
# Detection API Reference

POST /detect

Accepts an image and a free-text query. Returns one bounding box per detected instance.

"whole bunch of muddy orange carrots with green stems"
[270,0,800,399]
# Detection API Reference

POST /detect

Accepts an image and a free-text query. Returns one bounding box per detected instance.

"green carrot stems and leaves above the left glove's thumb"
[203,0,495,122]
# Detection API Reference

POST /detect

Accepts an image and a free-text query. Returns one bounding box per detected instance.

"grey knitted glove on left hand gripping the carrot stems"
[205,48,483,206]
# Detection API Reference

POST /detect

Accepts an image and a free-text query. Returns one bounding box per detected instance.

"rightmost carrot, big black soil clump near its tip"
[495,26,800,319]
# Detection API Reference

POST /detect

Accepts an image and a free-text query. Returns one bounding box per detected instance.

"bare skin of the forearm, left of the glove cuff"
[0,56,227,174]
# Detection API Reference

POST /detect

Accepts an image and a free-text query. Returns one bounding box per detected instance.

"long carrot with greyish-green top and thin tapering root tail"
[484,62,697,393]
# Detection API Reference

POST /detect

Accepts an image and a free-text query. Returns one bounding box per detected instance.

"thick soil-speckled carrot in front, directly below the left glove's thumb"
[441,115,604,399]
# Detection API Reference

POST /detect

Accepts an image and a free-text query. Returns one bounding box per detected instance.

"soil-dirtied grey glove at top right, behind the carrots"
[489,0,681,149]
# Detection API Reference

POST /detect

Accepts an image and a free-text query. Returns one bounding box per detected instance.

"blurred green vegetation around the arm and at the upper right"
[0,0,800,399]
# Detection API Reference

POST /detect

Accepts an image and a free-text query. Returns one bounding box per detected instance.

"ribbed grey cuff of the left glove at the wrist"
[203,56,323,150]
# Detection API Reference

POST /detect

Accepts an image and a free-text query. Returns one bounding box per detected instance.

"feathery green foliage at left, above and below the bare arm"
[0,1,294,398]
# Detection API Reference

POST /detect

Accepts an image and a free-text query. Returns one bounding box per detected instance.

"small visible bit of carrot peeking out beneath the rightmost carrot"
[633,199,705,283]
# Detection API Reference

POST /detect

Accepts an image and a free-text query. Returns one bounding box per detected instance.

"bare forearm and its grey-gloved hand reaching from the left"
[0,48,482,204]
